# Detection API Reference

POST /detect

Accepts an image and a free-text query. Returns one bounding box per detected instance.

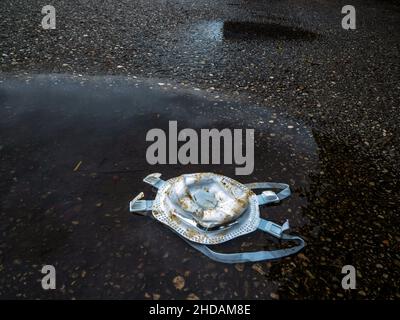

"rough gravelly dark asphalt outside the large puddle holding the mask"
[0,0,400,299]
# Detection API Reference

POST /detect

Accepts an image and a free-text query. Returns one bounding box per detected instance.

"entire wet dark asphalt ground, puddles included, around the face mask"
[0,0,400,299]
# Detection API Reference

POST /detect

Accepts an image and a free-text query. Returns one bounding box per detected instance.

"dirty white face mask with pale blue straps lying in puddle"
[129,173,304,263]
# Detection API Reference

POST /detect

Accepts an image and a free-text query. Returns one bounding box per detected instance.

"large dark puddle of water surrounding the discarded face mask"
[0,75,318,299]
